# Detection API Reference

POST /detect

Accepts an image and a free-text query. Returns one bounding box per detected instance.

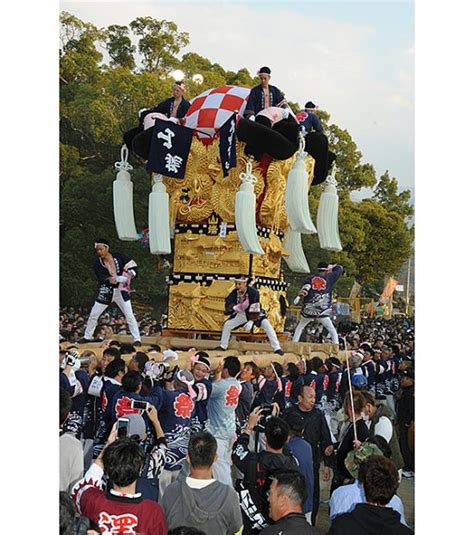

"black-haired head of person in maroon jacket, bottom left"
[103,437,145,487]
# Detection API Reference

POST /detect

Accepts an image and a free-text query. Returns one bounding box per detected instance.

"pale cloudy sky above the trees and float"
[60,0,414,199]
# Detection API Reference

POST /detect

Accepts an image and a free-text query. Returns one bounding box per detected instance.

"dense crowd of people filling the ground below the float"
[59,316,415,535]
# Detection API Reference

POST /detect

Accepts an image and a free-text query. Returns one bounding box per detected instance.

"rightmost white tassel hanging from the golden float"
[317,163,342,252]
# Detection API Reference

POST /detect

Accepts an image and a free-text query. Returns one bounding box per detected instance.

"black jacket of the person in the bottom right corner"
[328,503,413,535]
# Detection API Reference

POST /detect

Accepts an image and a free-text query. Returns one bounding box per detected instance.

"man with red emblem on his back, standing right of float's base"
[293,262,344,344]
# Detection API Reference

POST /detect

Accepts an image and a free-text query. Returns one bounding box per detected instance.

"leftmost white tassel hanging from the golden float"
[113,145,138,241]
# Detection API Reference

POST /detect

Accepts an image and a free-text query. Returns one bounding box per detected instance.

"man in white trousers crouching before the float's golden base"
[217,276,284,355]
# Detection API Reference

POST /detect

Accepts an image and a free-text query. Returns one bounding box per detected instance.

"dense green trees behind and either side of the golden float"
[60,12,414,306]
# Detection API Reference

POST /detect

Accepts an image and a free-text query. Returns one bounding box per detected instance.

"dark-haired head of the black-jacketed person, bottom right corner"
[358,455,399,506]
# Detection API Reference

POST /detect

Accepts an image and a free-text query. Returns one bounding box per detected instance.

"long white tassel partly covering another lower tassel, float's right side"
[285,133,316,234]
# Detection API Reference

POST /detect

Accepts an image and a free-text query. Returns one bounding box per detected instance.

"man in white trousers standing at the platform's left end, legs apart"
[79,239,141,345]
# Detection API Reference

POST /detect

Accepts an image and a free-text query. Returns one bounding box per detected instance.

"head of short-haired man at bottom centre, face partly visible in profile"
[268,470,308,522]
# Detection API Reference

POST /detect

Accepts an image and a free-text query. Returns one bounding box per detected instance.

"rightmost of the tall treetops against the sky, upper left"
[130,17,189,75]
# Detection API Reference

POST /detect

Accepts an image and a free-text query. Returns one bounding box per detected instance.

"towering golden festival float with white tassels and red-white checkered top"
[114,85,342,360]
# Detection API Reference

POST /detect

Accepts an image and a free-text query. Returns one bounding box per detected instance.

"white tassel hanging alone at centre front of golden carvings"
[235,161,264,255]
